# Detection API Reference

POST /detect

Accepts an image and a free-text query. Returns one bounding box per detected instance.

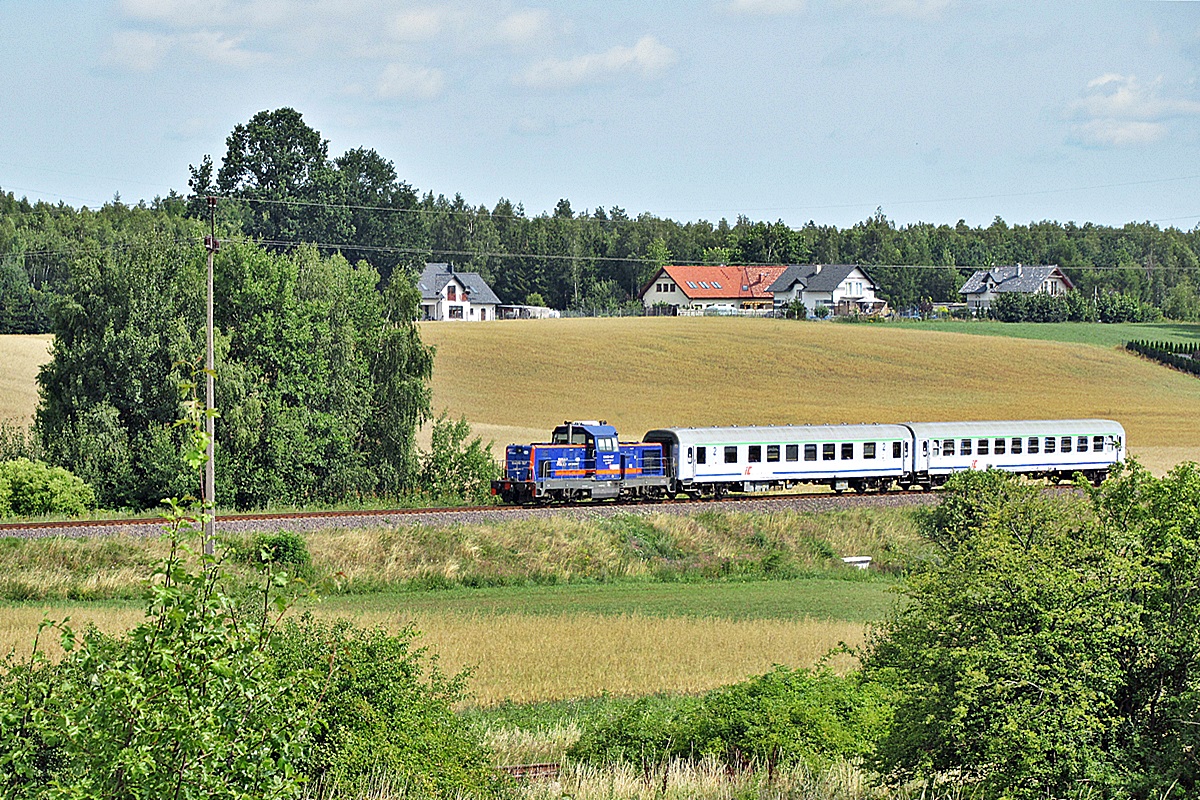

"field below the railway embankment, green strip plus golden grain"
[0,581,893,705]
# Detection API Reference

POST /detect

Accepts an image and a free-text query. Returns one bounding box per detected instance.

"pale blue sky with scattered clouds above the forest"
[0,0,1200,230]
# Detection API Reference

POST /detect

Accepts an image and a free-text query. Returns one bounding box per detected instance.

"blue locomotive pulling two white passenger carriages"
[492,420,1126,504]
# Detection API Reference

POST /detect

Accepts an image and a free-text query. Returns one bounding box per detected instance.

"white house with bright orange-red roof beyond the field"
[641,265,787,311]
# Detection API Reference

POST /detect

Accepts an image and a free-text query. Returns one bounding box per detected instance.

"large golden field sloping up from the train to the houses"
[421,317,1200,473]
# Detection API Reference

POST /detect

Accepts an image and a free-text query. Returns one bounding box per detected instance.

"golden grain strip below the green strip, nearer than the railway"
[0,600,865,705]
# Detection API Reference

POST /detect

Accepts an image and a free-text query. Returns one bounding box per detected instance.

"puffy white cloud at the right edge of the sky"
[1068,72,1200,146]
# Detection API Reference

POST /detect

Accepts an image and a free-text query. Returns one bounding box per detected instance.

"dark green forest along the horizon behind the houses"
[7,108,1200,333]
